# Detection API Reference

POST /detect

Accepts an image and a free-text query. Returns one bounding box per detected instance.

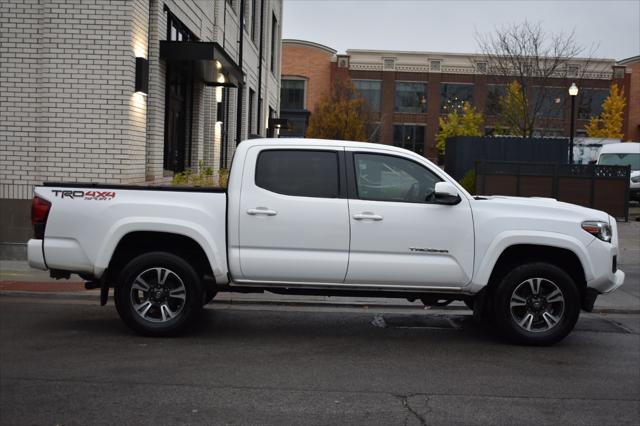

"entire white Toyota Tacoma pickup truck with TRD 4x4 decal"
[28,139,624,345]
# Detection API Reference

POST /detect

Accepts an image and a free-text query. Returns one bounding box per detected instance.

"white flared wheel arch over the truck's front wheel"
[471,230,594,291]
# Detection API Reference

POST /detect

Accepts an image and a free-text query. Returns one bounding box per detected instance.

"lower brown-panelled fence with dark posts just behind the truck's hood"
[475,161,631,221]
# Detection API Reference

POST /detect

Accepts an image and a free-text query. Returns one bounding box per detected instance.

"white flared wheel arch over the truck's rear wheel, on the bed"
[94,217,227,283]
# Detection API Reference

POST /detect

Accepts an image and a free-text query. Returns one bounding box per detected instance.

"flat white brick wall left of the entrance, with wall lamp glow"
[0,0,147,198]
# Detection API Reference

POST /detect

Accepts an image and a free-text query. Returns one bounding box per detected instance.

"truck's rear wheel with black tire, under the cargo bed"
[114,252,203,336]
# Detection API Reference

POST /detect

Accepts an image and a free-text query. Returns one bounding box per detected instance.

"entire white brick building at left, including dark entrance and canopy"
[0,0,282,257]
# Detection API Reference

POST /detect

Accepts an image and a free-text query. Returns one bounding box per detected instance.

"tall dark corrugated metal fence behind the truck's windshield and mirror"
[444,136,569,180]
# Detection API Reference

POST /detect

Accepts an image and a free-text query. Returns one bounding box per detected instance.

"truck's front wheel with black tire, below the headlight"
[493,263,580,346]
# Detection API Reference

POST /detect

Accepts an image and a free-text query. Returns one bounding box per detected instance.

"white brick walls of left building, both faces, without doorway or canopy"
[0,0,282,257]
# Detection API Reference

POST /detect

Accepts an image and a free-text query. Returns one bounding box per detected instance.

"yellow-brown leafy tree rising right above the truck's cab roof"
[307,80,369,142]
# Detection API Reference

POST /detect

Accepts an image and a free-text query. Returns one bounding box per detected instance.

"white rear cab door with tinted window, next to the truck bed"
[234,145,349,283]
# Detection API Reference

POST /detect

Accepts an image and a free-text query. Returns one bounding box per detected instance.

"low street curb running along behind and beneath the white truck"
[0,290,640,314]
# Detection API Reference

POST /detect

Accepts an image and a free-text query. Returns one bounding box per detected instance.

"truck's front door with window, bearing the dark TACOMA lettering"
[345,152,474,287]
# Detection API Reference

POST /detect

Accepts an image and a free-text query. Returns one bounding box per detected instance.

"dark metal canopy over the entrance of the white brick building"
[160,40,243,87]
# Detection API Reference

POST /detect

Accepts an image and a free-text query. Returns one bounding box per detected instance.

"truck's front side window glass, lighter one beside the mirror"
[354,154,441,203]
